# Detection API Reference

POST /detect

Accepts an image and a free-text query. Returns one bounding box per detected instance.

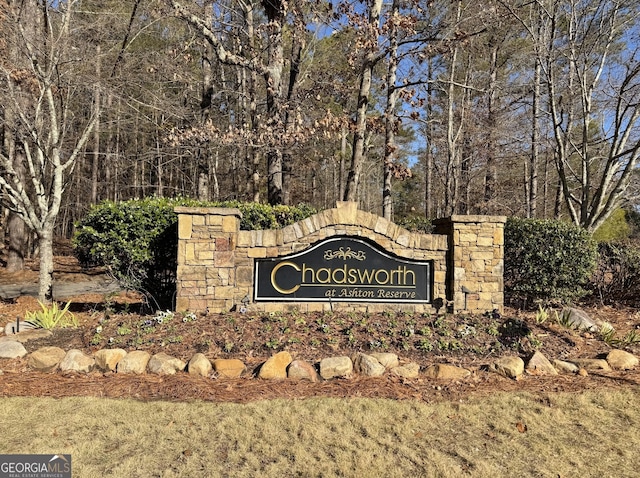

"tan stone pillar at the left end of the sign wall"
[175,207,242,312]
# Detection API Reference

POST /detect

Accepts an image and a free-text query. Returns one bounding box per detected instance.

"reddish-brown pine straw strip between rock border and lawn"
[0,371,640,403]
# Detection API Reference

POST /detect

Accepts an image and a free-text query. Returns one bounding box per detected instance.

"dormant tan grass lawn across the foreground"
[0,384,640,478]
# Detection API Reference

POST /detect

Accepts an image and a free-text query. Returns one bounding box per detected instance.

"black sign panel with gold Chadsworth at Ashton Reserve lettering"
[254,237,433,303]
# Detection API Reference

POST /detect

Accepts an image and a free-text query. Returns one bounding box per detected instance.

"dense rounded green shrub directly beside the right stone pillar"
[504,218,597,303]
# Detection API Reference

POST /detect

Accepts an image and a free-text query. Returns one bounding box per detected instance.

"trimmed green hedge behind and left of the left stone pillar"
[73,197,316,309]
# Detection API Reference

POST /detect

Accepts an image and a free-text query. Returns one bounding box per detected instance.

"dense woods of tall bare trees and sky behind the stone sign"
[0,0,640,298]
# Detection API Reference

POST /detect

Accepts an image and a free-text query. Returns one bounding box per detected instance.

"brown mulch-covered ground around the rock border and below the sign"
[0,252,640,402]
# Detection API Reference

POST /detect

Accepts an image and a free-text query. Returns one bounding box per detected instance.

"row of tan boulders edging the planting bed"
[0,334,639,382]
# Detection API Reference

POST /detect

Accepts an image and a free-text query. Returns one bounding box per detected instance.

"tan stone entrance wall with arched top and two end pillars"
[176,202,506,312]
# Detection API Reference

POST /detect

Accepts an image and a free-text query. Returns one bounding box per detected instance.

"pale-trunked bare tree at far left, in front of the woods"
[0,0,95,301]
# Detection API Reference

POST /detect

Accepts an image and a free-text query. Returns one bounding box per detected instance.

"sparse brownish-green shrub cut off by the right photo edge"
[589,242,640,304]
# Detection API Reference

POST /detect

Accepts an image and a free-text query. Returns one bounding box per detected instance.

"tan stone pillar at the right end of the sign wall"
[434,215,507,313]
